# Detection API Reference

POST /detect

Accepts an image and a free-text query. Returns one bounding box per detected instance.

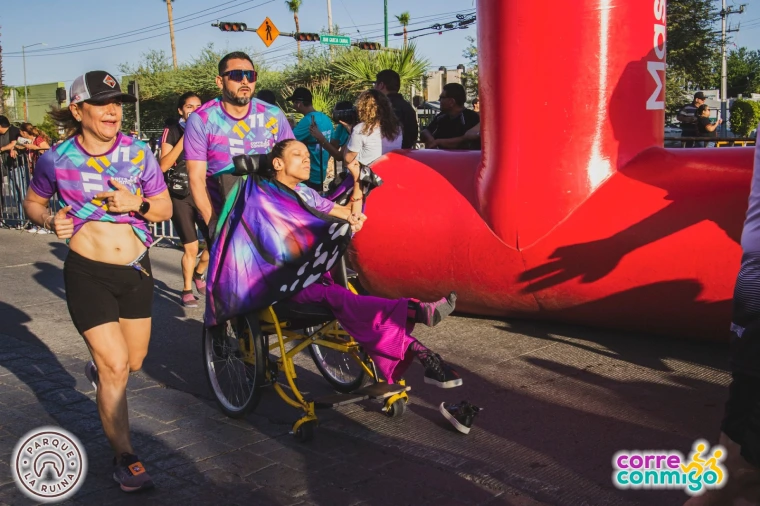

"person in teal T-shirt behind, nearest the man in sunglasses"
[286,88,333,192]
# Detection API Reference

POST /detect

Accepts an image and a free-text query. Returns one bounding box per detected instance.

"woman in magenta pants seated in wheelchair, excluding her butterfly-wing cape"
[259,139,462,388]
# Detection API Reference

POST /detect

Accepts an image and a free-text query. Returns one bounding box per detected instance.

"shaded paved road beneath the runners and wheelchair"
[0,230,729,506]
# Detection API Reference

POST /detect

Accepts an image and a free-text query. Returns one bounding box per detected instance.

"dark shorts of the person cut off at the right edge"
[721,253,760,467]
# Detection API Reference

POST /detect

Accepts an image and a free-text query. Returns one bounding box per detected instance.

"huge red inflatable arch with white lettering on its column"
[351,0,753,339]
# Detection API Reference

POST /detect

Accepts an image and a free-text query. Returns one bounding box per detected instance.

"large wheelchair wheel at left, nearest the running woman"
[203,315,266,418]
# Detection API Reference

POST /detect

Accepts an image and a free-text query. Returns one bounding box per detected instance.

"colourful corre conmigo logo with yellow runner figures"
[612,439,728,495]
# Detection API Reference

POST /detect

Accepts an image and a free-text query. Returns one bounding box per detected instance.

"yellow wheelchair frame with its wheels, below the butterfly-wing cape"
[204,284,410,442]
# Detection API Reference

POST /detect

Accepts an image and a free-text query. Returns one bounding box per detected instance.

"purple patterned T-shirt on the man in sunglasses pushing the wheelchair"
[184,98,294,213]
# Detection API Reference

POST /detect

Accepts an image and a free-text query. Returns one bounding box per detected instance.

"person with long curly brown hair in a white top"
[343,89,403,165]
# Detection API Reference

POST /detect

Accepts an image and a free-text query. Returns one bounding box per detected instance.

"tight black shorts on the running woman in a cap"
[63,251,153,335]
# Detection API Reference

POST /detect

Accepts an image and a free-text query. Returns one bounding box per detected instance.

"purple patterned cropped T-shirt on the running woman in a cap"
[29,133,166,247]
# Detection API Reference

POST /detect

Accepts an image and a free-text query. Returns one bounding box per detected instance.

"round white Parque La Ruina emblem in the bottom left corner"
[11,426,87,503]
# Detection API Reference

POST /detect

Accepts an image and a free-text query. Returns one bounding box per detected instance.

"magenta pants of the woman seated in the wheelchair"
[290,276,415,383]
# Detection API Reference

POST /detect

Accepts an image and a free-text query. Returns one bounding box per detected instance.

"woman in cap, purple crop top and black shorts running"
[24,71,172,492]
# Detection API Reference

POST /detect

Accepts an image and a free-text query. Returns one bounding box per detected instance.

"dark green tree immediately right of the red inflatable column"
[665,0,720,113]
